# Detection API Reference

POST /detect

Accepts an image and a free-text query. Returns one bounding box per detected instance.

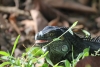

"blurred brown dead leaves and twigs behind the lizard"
[0,0,100,57]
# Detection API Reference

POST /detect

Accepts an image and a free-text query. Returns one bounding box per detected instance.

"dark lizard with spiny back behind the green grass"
[35,26,100,64]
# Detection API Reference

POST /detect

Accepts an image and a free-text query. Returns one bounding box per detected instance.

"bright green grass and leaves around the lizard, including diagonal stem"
[0,22,97,67]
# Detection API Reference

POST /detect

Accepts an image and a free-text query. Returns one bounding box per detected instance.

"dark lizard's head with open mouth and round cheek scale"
[35,26,70,63]
